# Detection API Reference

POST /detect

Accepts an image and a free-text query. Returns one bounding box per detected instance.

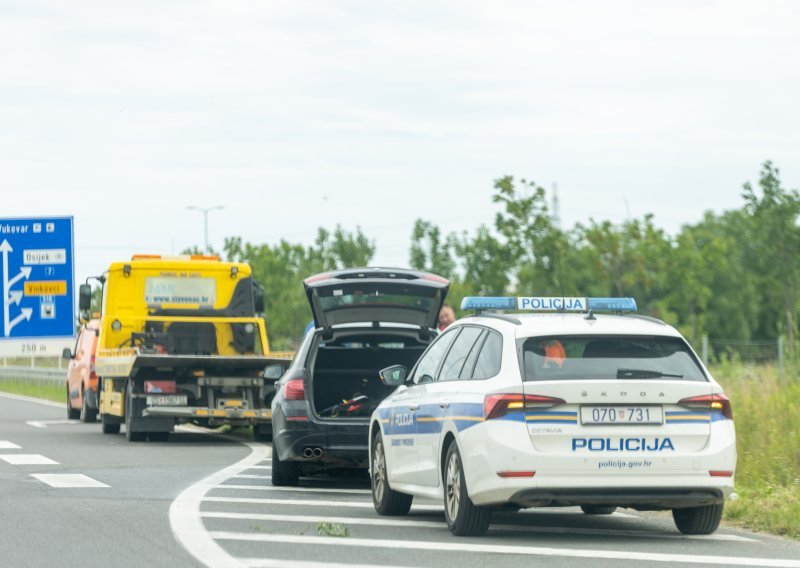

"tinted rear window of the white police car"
[520,336,707,381]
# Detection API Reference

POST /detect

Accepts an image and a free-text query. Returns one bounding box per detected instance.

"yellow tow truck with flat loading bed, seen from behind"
[79,255,291,441]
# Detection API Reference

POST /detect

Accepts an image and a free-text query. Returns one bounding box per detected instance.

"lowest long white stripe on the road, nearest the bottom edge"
[210,532,800,568]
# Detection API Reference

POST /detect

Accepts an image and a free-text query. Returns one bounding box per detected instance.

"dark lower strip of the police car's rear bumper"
[508,487,725,511]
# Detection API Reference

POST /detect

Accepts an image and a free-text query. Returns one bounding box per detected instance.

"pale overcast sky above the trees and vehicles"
[0,0,800,280]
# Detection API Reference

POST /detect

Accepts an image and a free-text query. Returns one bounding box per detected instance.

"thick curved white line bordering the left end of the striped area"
[169,438,270,568]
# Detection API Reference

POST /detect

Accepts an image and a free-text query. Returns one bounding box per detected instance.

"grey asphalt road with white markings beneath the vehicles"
[0,394,800,568]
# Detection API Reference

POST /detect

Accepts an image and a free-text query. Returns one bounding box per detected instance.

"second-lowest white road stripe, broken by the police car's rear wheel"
[201,511,759,542]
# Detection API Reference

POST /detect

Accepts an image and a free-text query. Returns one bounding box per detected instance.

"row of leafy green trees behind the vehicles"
[219,162,800,356]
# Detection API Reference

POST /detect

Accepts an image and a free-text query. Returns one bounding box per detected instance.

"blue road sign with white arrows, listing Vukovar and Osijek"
[0,217,75,341]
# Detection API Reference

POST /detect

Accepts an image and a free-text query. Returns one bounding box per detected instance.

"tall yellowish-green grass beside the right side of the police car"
[711,363,800,539]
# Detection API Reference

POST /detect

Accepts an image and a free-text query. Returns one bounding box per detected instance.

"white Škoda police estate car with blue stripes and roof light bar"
[369,297,736,536]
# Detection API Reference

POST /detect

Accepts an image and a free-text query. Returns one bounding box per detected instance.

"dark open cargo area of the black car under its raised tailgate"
[309,330,428,422]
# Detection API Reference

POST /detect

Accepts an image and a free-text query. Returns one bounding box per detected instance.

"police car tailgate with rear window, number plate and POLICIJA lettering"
[520,335,716,464]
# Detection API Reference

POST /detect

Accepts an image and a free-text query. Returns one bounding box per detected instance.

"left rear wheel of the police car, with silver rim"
[444,441,492,536]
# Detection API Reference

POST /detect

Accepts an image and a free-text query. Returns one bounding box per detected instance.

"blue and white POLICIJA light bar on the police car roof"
[461,296,636,312]
